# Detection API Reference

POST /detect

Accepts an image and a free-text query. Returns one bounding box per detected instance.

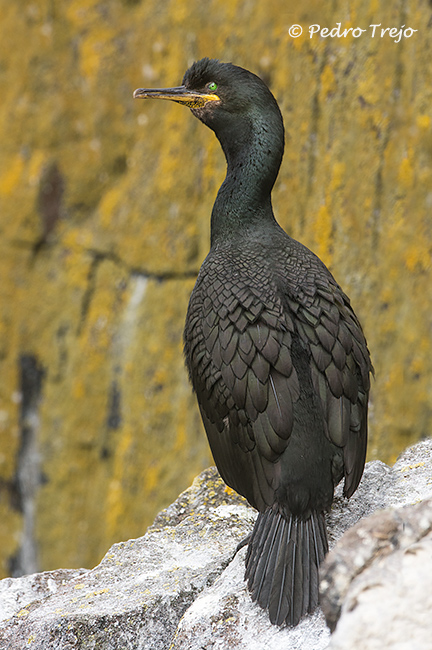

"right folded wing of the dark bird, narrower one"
[288,279,373,497]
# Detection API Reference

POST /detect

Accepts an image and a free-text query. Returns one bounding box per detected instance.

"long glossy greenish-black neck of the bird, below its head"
[211,111,283,247]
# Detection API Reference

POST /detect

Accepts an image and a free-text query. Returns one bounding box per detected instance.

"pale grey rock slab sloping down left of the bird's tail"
[0,469,255,650]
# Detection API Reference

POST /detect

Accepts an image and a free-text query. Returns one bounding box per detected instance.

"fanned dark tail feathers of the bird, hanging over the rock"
[245,508,328,625]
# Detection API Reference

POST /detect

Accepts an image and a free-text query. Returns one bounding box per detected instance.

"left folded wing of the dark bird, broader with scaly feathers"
[186,283,299,510]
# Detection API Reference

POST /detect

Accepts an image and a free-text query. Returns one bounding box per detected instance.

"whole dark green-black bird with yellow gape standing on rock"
[134,59,372,625]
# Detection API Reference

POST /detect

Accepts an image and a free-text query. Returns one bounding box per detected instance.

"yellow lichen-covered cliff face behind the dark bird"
[0,0,432,575]
